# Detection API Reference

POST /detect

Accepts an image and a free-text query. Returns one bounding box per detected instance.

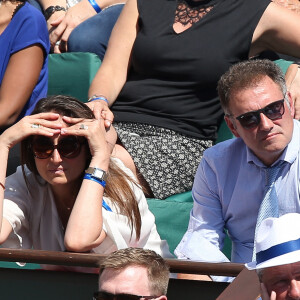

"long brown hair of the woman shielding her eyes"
[21,95,141,239]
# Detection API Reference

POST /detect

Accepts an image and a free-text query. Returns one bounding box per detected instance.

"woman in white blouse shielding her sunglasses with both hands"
[0,96,170,268]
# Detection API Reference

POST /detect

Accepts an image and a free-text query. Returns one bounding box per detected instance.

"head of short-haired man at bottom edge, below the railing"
[94,248,169,300]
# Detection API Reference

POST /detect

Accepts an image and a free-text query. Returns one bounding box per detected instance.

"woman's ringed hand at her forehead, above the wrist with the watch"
[61,116,116,159]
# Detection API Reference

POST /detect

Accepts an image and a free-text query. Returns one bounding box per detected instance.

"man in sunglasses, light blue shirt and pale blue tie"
[175,60,300,279]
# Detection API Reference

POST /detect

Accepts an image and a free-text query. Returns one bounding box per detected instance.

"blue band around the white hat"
[256,239,300,264]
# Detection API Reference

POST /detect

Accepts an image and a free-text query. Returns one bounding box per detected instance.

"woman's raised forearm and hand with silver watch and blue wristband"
[61,117,113,252]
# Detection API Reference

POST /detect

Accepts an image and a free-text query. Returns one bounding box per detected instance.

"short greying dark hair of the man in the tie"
[218,59,287,114]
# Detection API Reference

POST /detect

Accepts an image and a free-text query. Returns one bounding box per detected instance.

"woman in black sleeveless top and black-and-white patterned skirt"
[88,0,300,199]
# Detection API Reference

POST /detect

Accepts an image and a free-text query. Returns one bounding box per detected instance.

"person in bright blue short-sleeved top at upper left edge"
[0,0,50,133]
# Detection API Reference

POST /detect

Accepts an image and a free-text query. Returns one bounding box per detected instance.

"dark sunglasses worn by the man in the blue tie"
[228,99,284,129]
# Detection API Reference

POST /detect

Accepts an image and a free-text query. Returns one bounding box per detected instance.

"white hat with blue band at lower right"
[246,213,300,270]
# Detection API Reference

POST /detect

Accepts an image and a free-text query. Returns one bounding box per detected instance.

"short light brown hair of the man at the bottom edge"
[100,248,170,297]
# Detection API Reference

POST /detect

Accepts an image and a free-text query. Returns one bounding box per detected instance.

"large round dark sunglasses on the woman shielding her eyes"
[31,135,83,159]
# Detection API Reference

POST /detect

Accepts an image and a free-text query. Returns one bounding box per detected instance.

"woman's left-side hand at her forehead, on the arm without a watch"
[0,112,62,149]
